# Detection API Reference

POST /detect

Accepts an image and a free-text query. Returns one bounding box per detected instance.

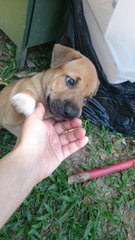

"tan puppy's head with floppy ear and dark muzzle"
[46,44,99,120]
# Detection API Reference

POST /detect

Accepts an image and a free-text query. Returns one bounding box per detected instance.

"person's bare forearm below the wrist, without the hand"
[0,149,34,228]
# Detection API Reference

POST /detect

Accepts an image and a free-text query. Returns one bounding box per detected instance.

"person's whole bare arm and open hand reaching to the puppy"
[0,103,88,228]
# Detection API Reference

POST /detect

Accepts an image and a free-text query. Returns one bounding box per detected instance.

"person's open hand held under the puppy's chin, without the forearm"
[16,103,88,184]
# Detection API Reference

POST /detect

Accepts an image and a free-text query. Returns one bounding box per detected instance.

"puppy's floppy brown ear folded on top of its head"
[51,44,82,68]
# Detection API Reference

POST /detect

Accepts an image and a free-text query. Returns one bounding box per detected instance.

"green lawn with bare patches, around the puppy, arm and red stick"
[0,30,135,240]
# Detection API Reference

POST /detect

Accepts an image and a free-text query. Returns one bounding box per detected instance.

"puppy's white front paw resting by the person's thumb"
[10,93,36,117]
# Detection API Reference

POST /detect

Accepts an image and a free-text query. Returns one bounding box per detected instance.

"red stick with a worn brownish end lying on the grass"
[68,159,135,184]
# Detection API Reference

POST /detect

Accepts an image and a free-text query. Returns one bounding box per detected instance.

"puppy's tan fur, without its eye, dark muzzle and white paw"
[0,44,99,136]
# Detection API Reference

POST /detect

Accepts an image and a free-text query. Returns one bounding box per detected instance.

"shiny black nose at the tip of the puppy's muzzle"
[63,102,80,118]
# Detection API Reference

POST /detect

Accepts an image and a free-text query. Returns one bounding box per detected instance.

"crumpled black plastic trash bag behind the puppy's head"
[57,0,135,136]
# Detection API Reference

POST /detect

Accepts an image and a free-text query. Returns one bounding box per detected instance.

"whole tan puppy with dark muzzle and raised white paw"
[0,44,99,136]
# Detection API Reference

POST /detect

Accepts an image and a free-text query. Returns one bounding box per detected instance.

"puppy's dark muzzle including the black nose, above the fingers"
[48,98,81,120]
